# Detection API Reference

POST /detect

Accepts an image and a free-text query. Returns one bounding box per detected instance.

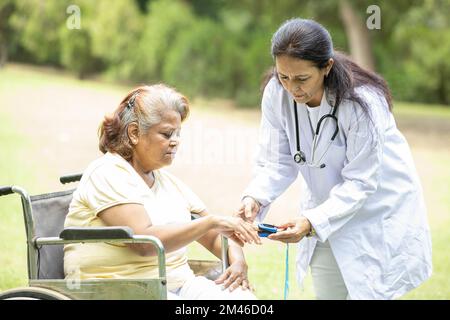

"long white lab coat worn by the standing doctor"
[244,78,432,299]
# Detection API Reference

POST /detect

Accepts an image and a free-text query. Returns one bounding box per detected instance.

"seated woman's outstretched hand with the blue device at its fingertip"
[214,216,261,247]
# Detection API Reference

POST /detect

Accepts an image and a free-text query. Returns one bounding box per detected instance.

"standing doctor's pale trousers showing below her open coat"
[310,241,350,300]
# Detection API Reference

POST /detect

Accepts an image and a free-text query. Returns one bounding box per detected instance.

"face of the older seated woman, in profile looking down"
[132,110,181,173]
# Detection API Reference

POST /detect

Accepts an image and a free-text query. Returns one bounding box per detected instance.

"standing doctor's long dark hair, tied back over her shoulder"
[263,18,392,111]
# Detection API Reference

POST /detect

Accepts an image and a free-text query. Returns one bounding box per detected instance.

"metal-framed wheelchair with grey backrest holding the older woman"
[0,174,228,300]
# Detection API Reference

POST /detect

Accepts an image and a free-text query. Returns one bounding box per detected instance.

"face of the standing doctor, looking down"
[275,55,333,107]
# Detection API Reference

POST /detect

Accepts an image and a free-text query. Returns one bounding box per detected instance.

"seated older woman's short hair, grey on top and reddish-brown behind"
[99,84,189,161]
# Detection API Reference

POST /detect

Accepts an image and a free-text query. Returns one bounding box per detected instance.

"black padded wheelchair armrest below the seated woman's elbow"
[59,227,133,240]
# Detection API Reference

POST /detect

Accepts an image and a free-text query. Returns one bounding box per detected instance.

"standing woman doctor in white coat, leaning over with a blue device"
[236,19,432,299]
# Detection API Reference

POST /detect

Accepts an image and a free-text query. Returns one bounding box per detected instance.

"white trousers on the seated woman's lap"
[167,276,256,300]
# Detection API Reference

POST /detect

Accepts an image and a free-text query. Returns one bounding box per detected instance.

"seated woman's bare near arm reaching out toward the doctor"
[99,204,258,256]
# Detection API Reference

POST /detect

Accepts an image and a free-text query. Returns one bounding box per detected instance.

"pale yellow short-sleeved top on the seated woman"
[64,153,205,290]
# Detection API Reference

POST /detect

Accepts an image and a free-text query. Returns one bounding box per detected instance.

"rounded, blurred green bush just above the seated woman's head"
[163,19,239,98]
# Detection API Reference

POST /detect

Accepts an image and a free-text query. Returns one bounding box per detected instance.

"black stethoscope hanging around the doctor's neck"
[294,100,339,169]
